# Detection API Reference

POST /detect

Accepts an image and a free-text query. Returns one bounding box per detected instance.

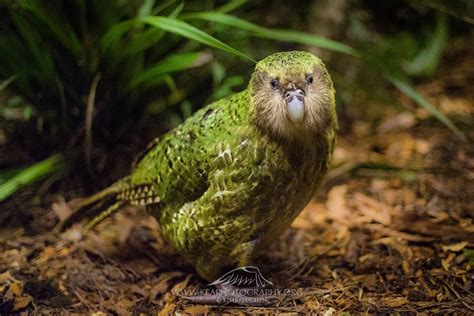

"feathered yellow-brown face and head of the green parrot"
[250,52,335,139]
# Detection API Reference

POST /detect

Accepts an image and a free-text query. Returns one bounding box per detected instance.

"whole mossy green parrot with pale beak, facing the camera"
[65,51,337,281]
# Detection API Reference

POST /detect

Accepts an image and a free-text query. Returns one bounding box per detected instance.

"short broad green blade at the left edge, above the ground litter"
[0,155,64,202]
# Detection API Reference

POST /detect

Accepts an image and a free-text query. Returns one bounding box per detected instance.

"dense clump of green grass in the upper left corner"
[0,0,253,130]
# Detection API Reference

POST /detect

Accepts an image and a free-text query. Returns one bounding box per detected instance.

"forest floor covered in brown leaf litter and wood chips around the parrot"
[0,49,474,315]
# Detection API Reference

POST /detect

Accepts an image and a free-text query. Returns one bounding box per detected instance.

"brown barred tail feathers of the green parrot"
[58,177,160,232]
